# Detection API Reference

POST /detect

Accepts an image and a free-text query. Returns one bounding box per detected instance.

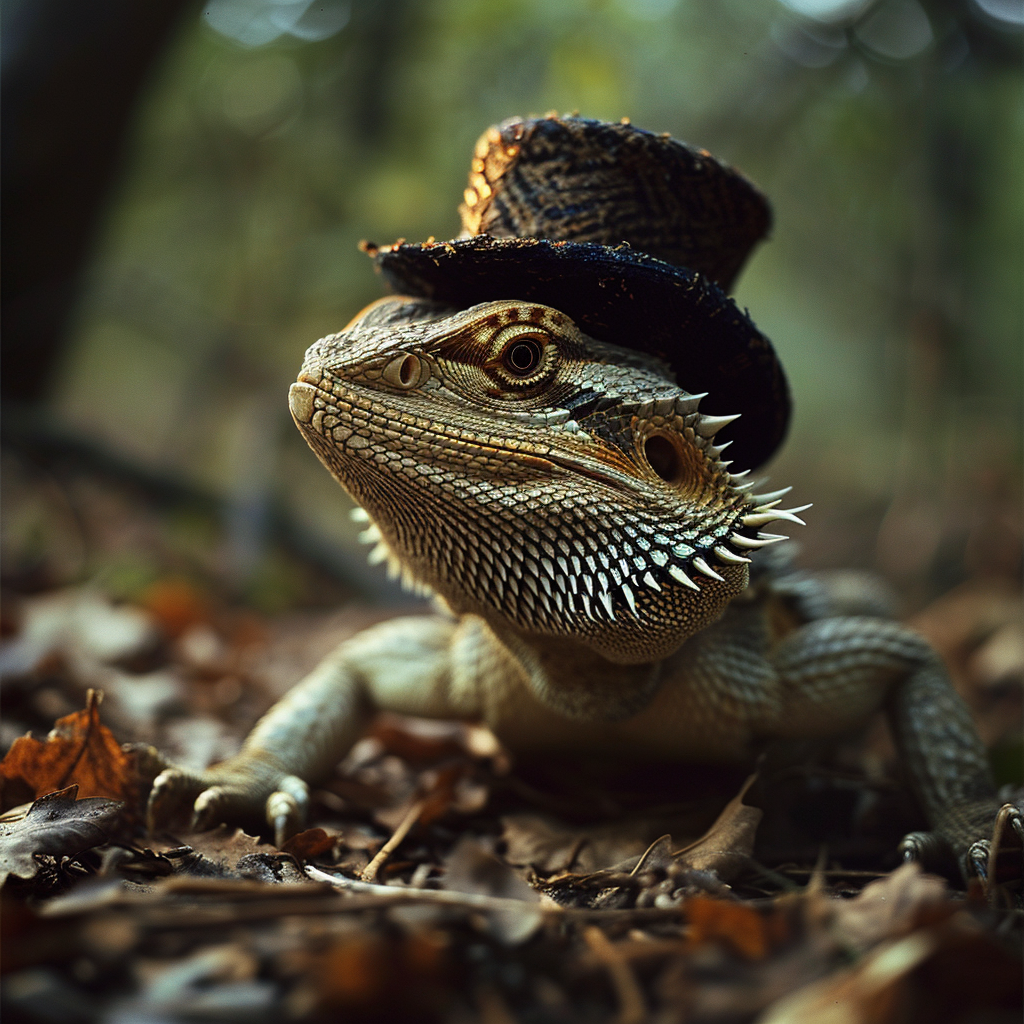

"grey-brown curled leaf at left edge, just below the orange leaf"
[0,785,123,885]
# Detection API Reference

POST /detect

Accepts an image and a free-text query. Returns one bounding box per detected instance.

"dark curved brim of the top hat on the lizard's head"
[367,236,790,471]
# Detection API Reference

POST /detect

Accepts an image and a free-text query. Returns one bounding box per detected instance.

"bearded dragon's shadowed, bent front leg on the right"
[770,617,1019,874]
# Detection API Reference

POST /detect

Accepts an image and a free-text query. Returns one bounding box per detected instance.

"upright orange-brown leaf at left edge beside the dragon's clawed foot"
[0,690,137,810]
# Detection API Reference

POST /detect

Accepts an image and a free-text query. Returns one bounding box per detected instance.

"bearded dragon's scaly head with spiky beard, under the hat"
[290,297,800,664]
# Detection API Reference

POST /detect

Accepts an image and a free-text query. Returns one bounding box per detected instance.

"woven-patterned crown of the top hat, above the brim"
[459,116,771,291]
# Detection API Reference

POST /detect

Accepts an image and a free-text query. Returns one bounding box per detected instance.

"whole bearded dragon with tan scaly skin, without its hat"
[151,297,1015,867]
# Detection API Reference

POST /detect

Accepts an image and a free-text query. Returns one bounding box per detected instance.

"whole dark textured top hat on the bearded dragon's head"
[366,117,790,470]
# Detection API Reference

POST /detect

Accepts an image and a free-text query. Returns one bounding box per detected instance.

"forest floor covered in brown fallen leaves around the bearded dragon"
[0,442,1024,1024]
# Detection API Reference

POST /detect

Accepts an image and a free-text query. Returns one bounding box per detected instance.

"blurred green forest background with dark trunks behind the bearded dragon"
[3,0,1024,611]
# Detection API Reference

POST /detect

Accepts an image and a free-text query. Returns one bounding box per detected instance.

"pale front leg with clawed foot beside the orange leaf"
[147,616,477,846]
